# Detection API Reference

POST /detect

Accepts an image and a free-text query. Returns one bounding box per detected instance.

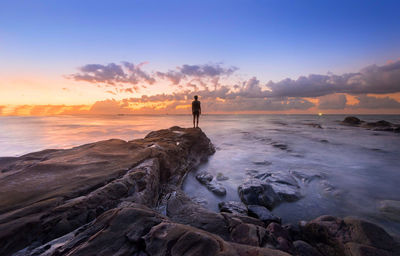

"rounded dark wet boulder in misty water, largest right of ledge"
[238,179,281,209]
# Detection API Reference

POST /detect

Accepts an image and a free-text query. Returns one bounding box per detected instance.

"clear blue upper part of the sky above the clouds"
[0,0,400,80]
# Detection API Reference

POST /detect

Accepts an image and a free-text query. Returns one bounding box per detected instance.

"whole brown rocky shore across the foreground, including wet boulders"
[0,127,399,256]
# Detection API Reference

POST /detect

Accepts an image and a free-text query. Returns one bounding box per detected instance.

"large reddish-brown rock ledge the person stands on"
[0,127,215,255]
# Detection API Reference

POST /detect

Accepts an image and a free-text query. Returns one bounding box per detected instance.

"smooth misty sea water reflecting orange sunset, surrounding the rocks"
[0,115,400,235]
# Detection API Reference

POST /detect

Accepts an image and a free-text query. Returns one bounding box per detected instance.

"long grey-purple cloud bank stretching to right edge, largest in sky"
[266,60,400,97]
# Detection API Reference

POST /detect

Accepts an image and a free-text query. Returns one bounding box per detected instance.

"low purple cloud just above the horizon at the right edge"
[350,95,400,109]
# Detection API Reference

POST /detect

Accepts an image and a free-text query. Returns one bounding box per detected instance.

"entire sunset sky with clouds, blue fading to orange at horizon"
[0,0,400,115]
